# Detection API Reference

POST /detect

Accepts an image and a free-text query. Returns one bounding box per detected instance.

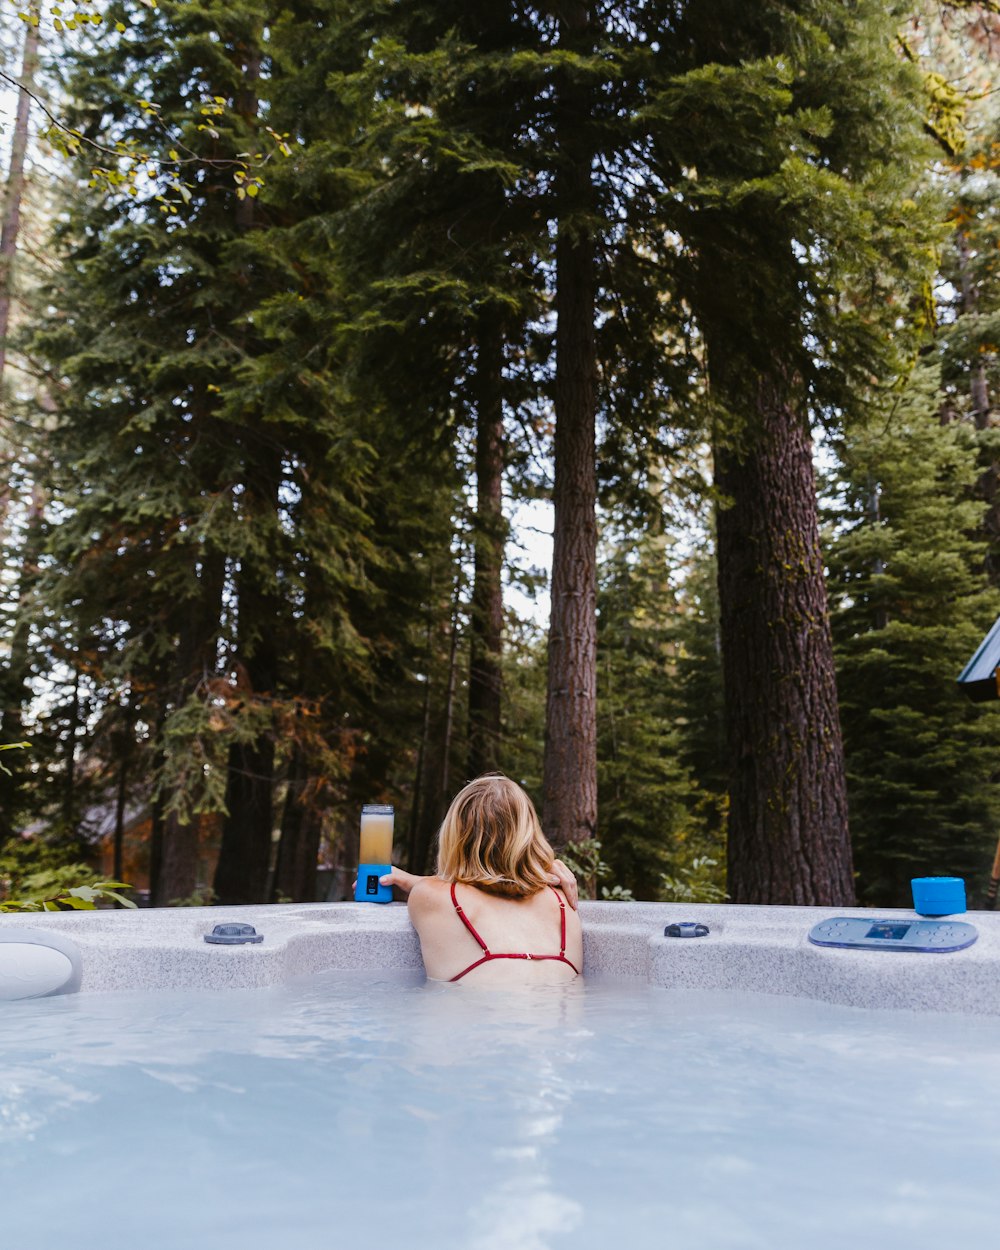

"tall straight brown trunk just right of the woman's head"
[543,0,598,846]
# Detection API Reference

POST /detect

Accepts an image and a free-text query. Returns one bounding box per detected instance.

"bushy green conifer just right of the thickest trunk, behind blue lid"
[830,365,1000,906]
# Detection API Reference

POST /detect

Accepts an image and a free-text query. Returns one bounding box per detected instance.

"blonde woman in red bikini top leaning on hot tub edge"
[381,774,584,986]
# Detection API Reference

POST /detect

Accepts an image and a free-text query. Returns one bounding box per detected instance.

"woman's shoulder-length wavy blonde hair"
[438,773,555,899]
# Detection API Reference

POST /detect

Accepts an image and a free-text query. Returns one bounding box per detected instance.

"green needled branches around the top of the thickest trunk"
[645,0,940,437]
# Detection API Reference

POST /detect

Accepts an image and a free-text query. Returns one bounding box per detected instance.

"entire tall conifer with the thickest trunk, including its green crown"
[648,0,940,904]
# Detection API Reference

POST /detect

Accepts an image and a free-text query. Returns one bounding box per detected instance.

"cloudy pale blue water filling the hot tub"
[0,973,1000,1250]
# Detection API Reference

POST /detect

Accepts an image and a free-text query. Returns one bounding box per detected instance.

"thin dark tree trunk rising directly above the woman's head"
[469,311,506,778]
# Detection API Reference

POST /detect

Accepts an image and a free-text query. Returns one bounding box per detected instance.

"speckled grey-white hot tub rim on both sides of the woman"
[0,903,1000,1015]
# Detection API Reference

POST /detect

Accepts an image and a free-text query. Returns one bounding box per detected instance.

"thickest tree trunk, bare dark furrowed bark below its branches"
[709,375,854,906]
